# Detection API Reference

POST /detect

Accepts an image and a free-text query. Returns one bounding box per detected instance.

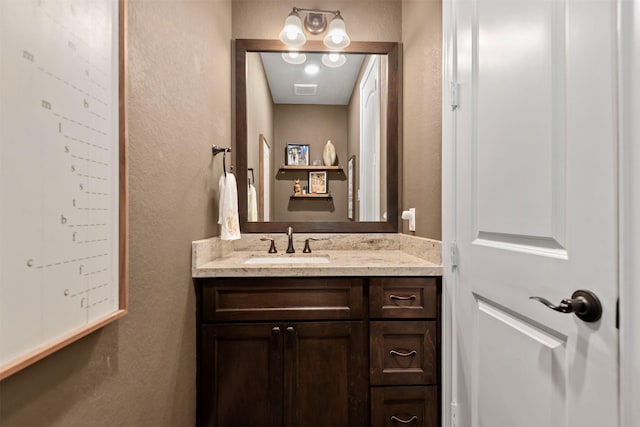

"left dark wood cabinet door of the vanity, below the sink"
[198,323,283,426]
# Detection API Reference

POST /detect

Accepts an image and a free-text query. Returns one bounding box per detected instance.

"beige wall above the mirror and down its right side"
[232,0,442,239]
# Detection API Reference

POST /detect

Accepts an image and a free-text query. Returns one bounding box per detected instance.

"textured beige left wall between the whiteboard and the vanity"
[0,0,231,427]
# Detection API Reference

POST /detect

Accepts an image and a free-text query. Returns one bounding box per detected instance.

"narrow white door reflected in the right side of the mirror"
[358,55,381,221]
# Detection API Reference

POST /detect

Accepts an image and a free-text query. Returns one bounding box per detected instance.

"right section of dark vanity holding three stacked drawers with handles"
[369,278,440,427]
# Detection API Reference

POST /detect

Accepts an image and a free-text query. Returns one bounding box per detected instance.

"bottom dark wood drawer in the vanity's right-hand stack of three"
[371,386,438,427]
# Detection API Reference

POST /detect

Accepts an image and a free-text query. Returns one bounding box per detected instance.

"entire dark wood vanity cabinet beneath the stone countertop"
[196,277,439,427]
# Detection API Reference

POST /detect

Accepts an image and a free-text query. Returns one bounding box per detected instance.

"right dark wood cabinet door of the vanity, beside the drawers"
[284,322,369,427]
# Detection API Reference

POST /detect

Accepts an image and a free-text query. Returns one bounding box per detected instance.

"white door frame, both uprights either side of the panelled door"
[441,0,640,426]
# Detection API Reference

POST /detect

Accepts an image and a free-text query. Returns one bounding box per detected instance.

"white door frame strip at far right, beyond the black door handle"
[616,0,640,426]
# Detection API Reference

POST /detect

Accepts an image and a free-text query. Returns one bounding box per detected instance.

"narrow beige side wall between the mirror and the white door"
[401,0,442,240]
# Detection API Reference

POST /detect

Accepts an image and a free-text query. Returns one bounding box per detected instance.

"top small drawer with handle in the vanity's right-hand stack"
[369,277,438,319]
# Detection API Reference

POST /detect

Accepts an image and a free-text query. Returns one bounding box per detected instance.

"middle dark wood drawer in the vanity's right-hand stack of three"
[369,320,438,385]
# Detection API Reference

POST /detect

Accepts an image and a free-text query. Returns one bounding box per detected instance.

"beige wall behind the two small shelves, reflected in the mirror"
[273,105,348,221]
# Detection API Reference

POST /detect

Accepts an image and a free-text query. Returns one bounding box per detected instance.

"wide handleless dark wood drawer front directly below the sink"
[201,278,364,322]
